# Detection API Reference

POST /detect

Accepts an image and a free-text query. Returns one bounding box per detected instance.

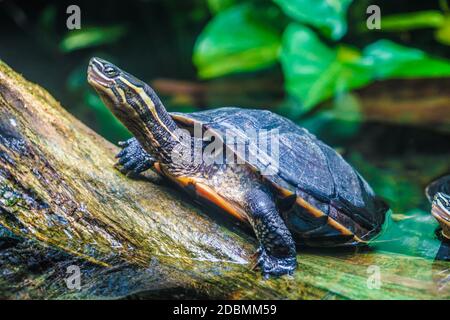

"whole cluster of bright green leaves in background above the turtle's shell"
[193,0,450,112]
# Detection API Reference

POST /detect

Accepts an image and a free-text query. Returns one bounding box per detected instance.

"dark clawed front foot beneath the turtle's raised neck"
[116,138,156,174]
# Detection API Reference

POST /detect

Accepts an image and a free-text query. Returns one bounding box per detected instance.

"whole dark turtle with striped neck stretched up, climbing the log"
[87,57,389,278]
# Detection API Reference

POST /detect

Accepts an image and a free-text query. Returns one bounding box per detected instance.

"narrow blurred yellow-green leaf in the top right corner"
[381,11,444,31]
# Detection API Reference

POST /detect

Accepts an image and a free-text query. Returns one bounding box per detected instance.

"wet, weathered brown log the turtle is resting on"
[0,62,450,299]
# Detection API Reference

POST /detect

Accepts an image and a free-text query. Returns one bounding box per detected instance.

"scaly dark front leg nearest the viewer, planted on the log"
[246,188,297,278]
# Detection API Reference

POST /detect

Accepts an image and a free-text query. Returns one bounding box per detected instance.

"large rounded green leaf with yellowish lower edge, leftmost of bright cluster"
[193,4,281,78]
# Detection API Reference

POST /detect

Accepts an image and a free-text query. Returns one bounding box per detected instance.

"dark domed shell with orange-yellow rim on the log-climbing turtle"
[172,107,388,246]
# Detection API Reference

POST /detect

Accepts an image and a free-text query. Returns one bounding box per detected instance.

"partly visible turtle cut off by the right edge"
[425,175,450,242]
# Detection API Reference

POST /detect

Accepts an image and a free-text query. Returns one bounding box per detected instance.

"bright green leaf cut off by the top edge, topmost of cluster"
[274,0,352,40]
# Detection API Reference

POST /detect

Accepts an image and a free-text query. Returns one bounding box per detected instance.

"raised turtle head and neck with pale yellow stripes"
[87,58,177,158]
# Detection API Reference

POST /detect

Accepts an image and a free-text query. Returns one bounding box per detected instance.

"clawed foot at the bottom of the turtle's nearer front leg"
[252,248,297,280]
